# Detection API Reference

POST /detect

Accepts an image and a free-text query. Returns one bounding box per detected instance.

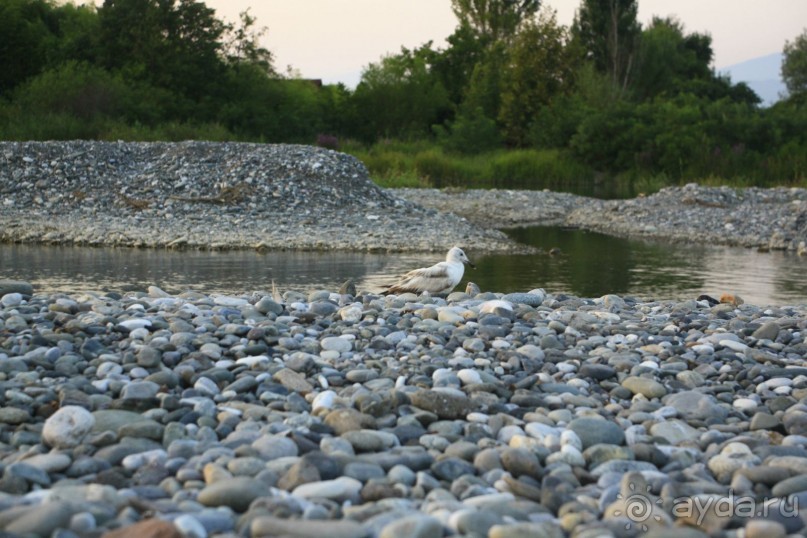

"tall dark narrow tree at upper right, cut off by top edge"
[572,0,641,90]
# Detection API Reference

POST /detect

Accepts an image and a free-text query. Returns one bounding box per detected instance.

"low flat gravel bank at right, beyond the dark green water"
[396,184,807,253]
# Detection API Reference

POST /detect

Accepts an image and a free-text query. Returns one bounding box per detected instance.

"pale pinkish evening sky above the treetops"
[205,0,807,87]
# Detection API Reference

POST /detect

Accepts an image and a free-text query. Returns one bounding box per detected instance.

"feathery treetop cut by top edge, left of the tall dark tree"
[451,0,541,41]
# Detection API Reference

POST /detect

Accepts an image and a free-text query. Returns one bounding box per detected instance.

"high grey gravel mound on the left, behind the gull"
[0,141,518,252]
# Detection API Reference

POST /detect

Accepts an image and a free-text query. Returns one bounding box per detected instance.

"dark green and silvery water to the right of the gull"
[483,227,807,304]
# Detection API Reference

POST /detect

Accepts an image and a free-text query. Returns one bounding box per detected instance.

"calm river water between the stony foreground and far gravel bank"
[0,227,807,305]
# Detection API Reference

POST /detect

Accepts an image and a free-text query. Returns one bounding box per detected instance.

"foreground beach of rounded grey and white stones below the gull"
[0,284,807,538]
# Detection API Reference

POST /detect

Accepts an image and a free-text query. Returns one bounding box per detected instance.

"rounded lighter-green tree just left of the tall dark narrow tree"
[498,12,575,146]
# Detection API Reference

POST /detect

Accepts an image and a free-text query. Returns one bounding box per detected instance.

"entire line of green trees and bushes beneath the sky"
[0,0,807,184]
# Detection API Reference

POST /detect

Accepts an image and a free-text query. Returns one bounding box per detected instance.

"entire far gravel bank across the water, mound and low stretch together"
[0,141,807,253]
